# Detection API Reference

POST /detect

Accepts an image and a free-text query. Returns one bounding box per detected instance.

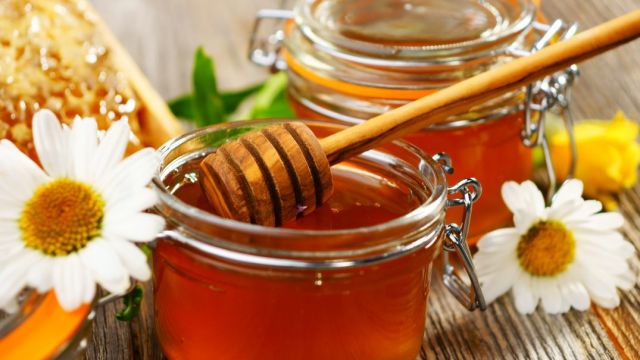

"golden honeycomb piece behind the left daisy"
[0,0,143,157]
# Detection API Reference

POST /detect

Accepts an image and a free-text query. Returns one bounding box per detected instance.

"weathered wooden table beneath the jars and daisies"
[86,0,640,359]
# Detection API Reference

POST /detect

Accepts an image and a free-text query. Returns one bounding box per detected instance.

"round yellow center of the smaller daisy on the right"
[517,221,576,276]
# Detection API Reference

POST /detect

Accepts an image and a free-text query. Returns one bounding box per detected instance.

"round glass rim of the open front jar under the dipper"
[152,119,447,238]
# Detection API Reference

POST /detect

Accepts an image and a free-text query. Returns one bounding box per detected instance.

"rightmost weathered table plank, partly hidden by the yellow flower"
[543,0,640,359]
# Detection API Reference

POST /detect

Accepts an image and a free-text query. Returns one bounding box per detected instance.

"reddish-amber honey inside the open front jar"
[154,164,436,360]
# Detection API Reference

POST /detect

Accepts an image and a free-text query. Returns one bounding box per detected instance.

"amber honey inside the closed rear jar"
[290,98,533,244]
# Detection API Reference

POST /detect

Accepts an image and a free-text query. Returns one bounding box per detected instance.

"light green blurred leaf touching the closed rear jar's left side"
[249,72,295,119]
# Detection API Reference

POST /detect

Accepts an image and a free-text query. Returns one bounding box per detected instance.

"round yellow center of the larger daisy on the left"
[19,178,104,256]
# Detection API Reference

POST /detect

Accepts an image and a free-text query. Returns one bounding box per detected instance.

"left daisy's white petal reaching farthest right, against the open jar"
[104,213,164,242]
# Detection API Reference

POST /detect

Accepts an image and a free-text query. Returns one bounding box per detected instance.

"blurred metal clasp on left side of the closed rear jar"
[249,9,293,71]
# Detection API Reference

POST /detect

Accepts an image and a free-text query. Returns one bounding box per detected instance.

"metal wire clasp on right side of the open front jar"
[433,153,487,311]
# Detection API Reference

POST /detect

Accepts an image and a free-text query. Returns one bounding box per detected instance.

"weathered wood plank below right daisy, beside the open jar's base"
[424,279,619,359]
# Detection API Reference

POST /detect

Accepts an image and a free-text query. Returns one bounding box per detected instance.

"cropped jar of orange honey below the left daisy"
[0,290,95,359]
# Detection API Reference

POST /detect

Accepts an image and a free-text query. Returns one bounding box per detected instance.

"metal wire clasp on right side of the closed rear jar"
[508,19,580,201]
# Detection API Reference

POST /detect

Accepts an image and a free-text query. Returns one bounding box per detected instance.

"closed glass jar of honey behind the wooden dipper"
[250,0,575,242]
